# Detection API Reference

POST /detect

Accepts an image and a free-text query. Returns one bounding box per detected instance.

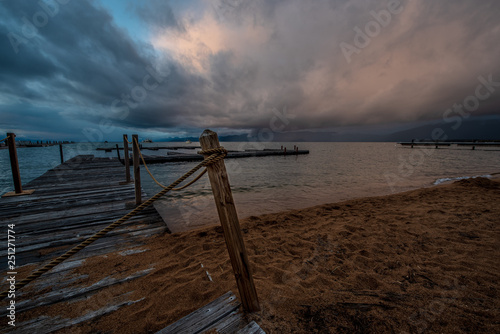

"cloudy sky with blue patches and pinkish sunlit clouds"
[0,0,500,141]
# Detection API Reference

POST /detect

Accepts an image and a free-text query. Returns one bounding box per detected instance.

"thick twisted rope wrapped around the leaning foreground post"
[0,147,227,300]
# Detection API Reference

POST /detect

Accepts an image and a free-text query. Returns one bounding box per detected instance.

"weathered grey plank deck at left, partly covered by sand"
[0,156,168,333]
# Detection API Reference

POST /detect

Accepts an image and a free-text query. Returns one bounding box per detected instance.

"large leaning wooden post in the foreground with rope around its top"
[200,130,260,312]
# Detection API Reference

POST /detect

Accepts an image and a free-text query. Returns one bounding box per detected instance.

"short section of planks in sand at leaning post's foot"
[156,291,241,334]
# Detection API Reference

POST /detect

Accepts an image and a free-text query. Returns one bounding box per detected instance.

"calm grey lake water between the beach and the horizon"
[0,142,500,231]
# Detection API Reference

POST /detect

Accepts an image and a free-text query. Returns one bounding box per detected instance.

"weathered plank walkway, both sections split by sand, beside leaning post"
[0,155,265,334]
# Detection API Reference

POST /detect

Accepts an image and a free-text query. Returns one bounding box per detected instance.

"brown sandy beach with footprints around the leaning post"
[19,178,500,333]
